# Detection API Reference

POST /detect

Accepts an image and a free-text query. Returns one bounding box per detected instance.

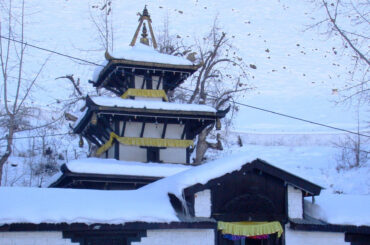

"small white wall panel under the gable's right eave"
[287,185,303,219]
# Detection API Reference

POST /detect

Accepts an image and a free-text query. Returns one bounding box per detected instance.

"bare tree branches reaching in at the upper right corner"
[311,0,370,104]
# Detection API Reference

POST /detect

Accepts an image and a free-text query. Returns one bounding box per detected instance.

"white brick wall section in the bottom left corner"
[0,231,76,245]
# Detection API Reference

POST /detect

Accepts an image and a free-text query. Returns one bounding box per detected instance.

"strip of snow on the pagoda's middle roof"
[91,96,216,113]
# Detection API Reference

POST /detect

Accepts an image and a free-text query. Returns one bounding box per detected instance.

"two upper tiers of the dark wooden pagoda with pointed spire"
[74,8,227,167]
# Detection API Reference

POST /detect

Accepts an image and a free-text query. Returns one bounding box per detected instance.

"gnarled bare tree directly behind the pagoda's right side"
[159,19,252,165]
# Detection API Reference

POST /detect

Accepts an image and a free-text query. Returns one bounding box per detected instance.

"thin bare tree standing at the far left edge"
[0,0,47,185]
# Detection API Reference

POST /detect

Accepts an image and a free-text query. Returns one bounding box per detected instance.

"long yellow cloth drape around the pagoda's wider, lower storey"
[96,132,194,156]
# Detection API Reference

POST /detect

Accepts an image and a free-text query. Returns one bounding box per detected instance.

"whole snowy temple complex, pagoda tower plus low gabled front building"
[0,5,370,245]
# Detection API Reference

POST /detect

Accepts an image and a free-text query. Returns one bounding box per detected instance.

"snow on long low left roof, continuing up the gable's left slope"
[0,155,251,224]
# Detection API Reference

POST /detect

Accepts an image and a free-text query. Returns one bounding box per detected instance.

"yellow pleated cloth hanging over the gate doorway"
[217,221,283,237]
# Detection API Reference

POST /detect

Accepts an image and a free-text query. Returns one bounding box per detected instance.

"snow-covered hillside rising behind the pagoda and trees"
[0,0,370,194]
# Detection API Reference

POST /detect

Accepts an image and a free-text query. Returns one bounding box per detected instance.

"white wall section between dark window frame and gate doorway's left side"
[131,229,215,245]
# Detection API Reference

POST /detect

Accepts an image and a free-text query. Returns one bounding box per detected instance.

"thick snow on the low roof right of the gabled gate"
[304,191,370,226]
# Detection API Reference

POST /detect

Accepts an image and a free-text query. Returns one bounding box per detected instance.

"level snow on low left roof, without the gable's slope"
[0,187,179,224]
